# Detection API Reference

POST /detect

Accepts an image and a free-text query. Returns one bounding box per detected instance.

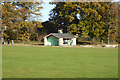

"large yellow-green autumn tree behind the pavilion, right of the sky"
[50,2,115,42]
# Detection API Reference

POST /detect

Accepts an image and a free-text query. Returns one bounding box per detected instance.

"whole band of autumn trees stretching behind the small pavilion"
[2,2,118,41]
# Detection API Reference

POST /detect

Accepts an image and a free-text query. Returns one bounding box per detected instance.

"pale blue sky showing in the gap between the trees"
[40,0,120,22]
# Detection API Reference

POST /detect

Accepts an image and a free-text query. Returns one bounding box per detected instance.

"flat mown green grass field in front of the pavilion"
[2,46,118,78]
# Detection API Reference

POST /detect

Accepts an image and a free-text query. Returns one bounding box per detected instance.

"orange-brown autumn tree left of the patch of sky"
[2,2,42,40]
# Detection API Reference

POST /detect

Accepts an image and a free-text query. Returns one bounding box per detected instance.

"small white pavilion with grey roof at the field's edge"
[44,33,76,46]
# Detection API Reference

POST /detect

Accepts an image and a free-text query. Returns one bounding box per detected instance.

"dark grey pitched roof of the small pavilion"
[45,33,75,38]
